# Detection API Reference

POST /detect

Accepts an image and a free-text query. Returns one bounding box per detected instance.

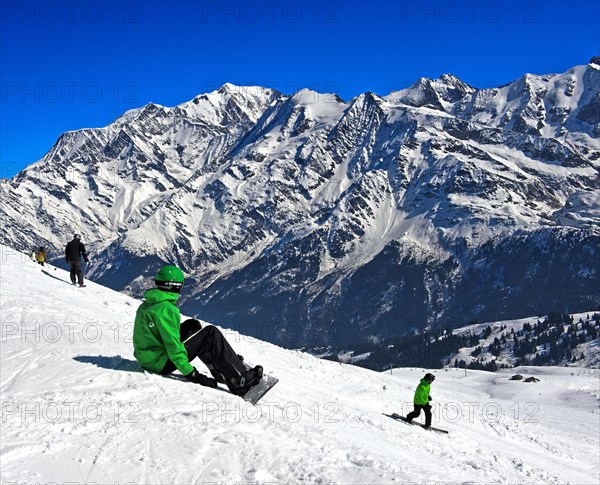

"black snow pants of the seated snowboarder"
[160,321,246,389]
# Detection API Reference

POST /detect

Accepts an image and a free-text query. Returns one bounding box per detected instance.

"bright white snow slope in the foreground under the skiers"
[0,247,600,485]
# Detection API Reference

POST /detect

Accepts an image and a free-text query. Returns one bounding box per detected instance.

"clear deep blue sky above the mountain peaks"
[0,0,600,177]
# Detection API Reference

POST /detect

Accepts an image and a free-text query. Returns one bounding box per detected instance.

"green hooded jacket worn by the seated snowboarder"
[133,288,194,375]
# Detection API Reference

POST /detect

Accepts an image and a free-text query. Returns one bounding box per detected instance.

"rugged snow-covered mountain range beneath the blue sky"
[0,58,600,346]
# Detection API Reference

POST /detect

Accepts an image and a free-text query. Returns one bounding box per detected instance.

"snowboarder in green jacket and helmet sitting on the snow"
[133,266,263,396]
